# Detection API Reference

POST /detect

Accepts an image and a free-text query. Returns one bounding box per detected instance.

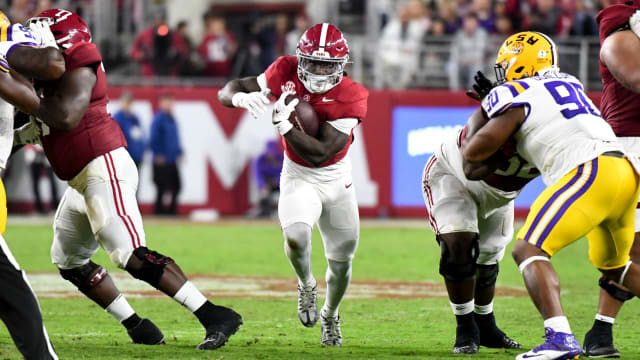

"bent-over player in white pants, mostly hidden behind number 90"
[422,110,528,354]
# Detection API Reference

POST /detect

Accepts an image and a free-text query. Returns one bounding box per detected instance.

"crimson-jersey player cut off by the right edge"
[583,0,640,357]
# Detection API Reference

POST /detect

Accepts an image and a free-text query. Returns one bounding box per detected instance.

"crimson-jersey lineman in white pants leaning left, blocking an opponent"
[8,9,242,350]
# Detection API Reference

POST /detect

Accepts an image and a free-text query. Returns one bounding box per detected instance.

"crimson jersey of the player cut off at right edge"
[596,4,640,137]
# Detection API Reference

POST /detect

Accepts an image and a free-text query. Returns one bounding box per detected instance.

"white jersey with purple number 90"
[482,71,623,185]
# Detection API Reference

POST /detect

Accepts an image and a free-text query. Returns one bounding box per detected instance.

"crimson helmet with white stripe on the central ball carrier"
[296,23,349,94]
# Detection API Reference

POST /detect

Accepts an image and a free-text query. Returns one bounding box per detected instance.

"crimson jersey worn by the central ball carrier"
[264,56,369,167]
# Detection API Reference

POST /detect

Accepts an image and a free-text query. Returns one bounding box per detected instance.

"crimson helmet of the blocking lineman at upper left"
[27,9,91,49]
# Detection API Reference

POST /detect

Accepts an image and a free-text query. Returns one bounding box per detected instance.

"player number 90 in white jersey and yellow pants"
[462,32,640,359]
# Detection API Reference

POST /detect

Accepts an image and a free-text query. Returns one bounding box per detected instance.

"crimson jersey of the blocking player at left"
[42,42,127,180]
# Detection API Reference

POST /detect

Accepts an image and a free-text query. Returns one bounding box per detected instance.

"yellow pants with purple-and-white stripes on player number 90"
[517,156,640,270]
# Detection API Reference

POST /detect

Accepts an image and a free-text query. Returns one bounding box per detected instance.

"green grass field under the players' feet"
[0,221,640,359]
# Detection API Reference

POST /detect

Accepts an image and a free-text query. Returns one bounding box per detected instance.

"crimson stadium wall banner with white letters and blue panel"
[5,86,599,217]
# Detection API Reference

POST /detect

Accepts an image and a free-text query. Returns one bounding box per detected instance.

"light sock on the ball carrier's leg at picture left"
[283,223,316,287]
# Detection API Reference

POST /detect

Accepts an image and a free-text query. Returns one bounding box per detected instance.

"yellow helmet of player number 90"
[495,31,558,83]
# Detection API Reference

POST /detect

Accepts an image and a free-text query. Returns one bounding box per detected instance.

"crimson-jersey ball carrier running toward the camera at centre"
[218,23,368,346]
